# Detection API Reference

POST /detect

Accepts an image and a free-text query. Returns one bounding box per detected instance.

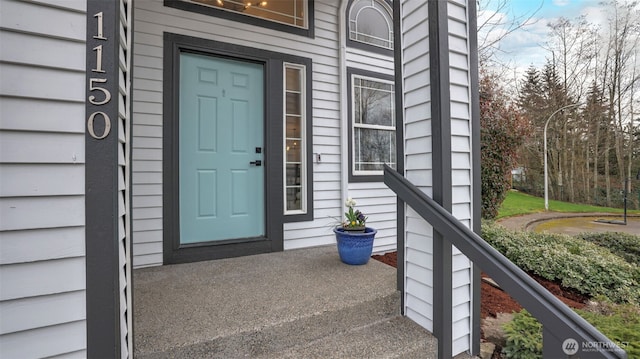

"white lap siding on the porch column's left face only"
[401,0,433,331]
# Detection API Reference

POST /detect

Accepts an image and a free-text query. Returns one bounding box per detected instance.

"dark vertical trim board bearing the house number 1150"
[85,0,122,358]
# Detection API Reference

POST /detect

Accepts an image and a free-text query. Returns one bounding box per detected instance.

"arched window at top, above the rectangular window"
[349,0,393,50]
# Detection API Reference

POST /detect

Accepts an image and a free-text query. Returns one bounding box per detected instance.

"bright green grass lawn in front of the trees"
[498,191,640,218]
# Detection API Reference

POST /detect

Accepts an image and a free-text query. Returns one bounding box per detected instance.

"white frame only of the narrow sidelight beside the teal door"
[282,62,309,215]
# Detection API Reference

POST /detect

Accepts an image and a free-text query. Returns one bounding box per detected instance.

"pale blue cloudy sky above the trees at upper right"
[478,0,606,79]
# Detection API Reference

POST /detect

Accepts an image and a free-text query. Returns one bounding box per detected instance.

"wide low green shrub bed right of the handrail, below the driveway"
[482,223,640,304]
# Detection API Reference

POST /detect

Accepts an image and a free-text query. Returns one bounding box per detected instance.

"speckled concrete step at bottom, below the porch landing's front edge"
[136,292,435,359]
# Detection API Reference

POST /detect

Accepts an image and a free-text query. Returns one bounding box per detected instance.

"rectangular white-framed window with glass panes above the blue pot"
[351,74,396,176]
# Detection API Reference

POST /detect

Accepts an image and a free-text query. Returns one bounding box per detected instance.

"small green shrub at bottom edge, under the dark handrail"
[502,309,542,359]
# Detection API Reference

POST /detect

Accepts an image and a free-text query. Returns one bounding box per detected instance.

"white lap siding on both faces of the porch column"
[401,0,478,355]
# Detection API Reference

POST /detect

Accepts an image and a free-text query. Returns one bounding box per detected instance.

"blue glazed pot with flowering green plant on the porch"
[333,198,378,265]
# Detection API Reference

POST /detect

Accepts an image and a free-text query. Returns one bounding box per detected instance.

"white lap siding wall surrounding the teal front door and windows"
[132,0,395,267]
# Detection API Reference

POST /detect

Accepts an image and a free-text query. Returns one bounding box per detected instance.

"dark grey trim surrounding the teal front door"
[163,33,284,264]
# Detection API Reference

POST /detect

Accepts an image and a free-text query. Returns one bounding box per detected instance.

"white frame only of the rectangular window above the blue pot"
[349,74,398,176]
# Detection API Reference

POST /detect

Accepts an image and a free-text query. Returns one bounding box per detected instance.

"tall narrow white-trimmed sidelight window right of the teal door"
[284,63,308,214]
